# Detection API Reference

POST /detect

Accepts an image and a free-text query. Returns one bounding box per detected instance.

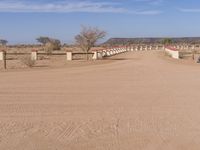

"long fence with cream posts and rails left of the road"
[0,45,164,69]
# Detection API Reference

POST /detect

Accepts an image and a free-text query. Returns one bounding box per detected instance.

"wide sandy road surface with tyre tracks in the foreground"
[0,52,200,150]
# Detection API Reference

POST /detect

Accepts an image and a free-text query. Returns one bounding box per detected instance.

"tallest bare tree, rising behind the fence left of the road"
[75,26,106,60]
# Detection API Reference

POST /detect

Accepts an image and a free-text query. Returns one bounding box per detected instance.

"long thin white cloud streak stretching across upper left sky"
[0,0,160,15]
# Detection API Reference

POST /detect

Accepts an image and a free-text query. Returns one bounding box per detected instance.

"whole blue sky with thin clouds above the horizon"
[0,0,200,43]
